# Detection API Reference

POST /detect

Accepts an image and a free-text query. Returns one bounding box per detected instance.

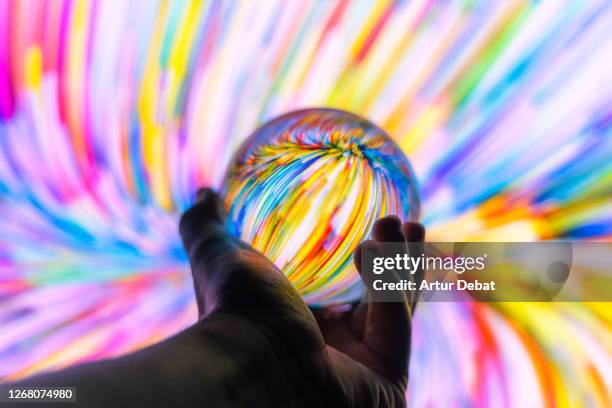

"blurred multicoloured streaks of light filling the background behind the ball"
[0,0,612,407]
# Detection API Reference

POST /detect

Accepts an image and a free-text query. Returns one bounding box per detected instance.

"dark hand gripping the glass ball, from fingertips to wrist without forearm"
[180,189,425,407]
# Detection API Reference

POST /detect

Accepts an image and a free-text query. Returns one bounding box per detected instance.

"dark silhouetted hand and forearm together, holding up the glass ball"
[14,189,425,408]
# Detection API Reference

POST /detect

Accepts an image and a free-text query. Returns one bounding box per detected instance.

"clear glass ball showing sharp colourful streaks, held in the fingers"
[223,108,419,306]
